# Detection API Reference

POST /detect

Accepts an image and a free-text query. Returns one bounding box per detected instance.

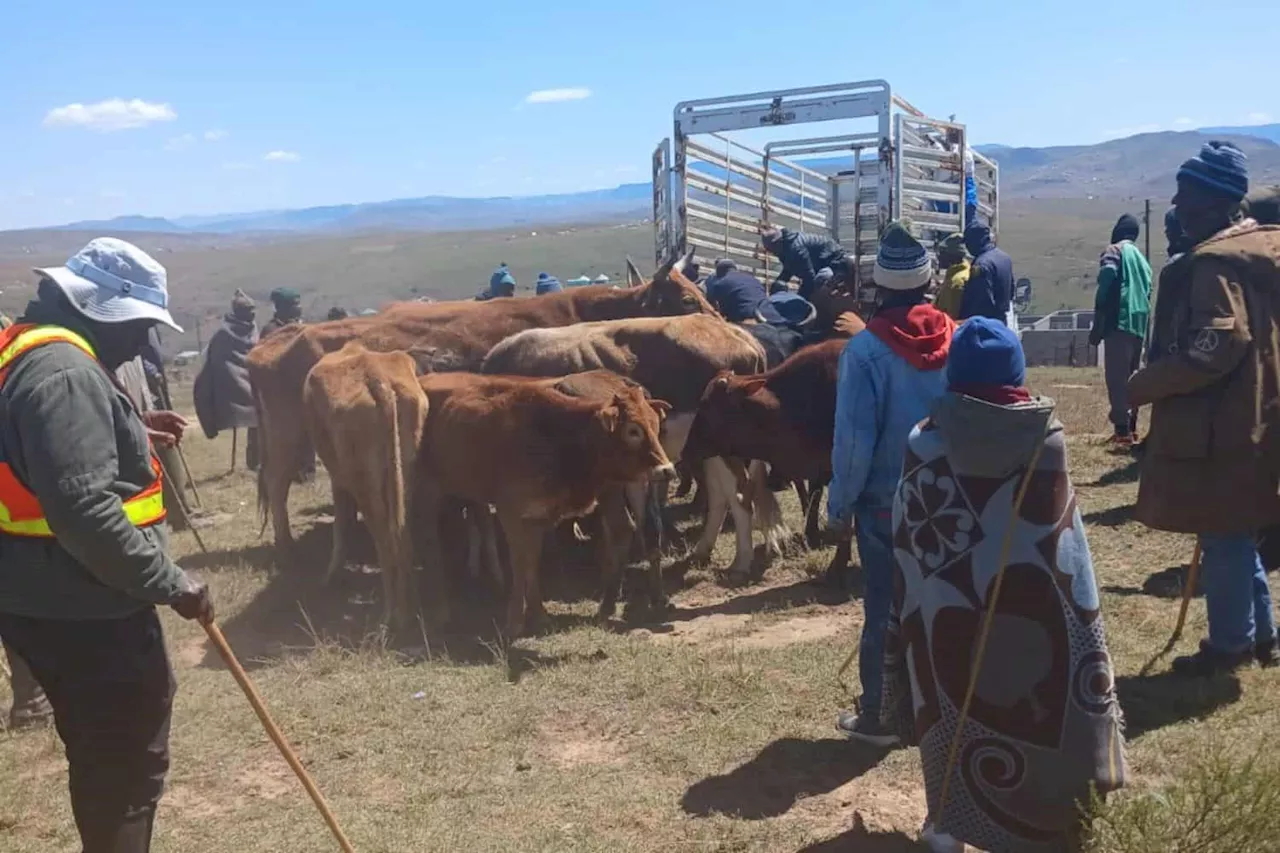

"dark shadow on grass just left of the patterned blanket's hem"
[680,738,888,819]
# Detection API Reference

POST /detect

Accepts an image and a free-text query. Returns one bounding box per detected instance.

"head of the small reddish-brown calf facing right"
[590,388,675,483]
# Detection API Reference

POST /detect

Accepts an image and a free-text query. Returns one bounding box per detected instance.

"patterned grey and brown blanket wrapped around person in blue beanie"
[883,394,1126,853]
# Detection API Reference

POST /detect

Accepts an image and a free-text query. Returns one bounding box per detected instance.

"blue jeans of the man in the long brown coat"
[1201,534,1276,652]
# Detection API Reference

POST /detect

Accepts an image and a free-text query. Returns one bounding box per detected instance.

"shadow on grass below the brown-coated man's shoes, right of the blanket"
[1116,670,1240,740]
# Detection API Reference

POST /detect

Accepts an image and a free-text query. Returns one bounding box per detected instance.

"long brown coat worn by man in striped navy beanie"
[1129,220,1280,534]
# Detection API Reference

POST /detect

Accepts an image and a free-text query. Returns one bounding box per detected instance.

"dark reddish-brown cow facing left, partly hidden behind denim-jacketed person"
[684,339,850,579]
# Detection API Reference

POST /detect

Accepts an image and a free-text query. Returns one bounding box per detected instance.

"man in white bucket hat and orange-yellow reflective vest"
[0,238,212,853]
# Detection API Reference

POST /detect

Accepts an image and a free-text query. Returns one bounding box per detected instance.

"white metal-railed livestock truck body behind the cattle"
[653,79,1000,305]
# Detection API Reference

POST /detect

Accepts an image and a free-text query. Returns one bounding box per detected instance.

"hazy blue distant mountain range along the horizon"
[47,124,1280,234]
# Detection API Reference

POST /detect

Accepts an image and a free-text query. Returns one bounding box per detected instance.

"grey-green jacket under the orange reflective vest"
[0,300,183,620]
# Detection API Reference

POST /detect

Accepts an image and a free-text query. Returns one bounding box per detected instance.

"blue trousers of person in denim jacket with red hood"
[854,508,893,719]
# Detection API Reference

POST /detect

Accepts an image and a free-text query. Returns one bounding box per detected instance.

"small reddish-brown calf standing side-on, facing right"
[419,373,675,637]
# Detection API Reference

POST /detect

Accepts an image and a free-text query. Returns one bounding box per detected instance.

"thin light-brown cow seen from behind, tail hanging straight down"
[302,341,430,633]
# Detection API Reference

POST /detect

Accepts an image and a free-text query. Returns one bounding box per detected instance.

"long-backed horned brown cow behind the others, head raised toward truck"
[248,249,716,547]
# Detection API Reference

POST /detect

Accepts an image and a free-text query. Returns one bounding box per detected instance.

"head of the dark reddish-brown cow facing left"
[680,370,782,462]
